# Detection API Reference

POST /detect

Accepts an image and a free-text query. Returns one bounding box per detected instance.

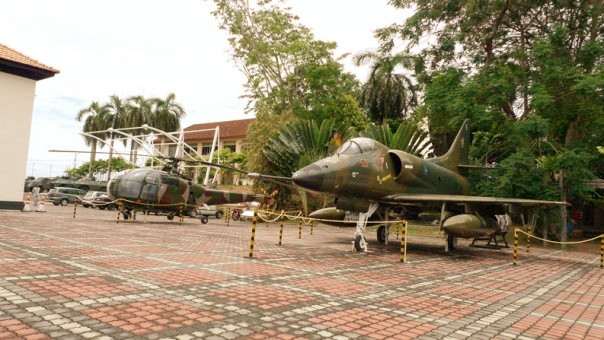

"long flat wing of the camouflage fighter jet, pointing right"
[379,194,569,206]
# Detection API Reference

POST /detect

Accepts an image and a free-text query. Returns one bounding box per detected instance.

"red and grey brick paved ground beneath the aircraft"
[0,207,604,339]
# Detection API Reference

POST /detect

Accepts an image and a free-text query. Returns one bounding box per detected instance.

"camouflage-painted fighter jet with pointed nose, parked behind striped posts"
[292,121,567,251]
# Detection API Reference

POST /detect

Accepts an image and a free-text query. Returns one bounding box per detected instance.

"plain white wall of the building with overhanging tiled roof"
[0,72,36,205]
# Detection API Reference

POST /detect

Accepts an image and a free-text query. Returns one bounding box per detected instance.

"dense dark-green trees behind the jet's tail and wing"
[377,0,604,205]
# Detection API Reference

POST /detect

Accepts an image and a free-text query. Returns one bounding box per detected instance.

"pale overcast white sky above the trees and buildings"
[0,0,403,176]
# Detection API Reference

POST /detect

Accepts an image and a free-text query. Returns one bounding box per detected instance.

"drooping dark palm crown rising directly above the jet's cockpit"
[354,52,418,124]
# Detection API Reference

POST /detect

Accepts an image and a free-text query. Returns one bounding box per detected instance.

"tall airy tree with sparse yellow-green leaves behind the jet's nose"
[213,0,368,171]
